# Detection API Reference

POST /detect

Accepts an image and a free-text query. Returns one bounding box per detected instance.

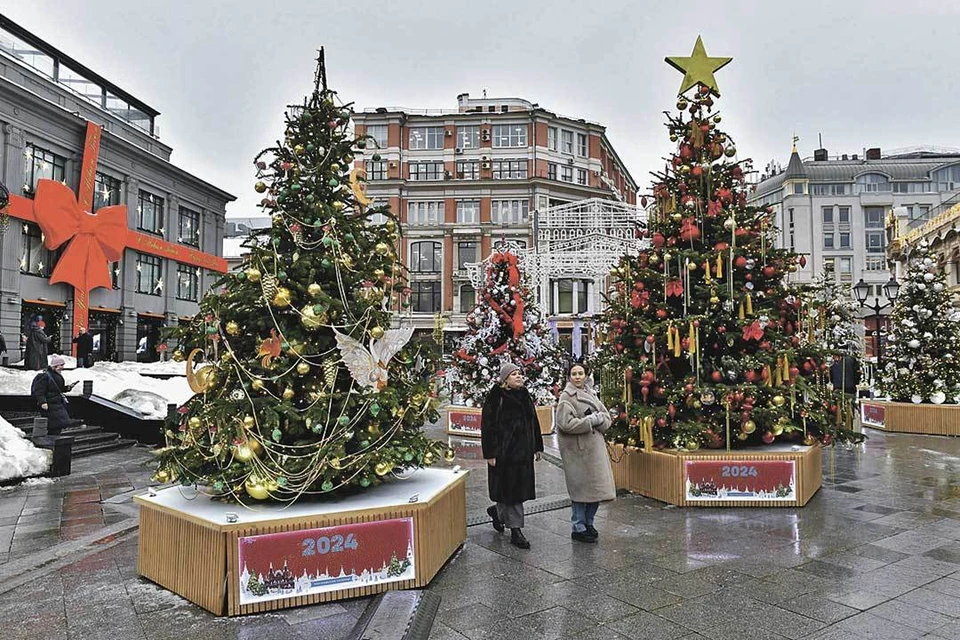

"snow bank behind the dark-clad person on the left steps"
[0,356,193,419]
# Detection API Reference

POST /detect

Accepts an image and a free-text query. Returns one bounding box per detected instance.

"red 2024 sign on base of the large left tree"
[237,518,416,604]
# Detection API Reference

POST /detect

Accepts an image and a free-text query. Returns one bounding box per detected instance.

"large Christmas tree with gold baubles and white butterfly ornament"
[157,51,451,501]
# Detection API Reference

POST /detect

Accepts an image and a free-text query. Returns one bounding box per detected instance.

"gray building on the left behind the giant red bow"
[0,15,235,362]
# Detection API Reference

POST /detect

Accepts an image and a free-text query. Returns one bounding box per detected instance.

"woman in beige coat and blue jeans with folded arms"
[556,364,616,542]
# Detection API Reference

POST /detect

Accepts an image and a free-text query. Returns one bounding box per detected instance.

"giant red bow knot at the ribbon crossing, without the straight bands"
[33,180,127,293]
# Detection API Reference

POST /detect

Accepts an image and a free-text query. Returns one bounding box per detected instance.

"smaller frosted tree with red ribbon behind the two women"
[447,245,564,406]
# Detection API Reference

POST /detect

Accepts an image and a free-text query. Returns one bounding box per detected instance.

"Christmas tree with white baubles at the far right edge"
[880,241,960,404]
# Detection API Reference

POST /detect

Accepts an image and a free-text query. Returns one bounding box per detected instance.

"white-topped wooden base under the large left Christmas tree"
[134,469,467,616]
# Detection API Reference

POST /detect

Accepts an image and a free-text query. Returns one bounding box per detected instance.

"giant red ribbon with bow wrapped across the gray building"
[6,121,227,350]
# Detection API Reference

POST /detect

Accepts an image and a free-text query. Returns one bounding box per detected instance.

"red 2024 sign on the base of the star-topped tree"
[685,460,796,502]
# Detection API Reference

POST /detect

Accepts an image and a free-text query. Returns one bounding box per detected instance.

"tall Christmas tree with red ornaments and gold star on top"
[598,38,862,449]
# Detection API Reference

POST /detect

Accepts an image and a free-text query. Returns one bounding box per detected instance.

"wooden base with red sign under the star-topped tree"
[609,445,822,507]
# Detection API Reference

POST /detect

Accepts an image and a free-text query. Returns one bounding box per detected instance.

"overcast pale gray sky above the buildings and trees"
[0,0,960,216]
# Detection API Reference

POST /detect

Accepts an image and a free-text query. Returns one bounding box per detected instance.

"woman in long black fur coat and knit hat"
[480,362,543,549]
